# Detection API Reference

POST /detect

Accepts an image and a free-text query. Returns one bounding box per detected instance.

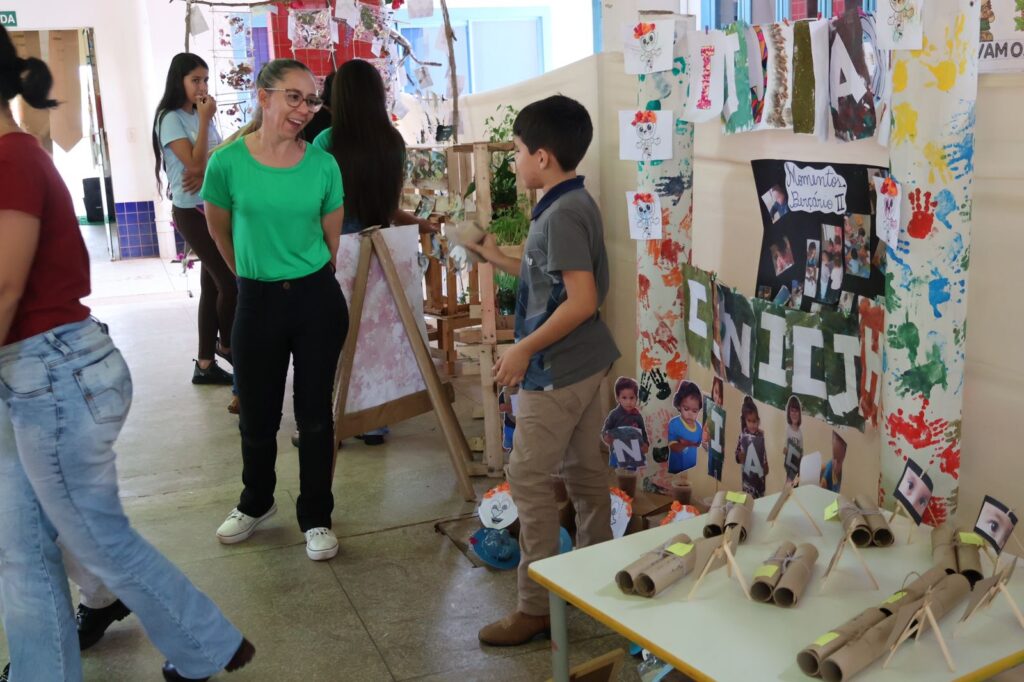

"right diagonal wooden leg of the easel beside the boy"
[370,231,476,502]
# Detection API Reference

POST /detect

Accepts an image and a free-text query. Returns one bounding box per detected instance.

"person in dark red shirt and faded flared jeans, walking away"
[0,27,255,682]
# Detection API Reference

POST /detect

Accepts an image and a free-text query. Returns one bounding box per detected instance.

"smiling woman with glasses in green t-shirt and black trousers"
[203,59,348,560]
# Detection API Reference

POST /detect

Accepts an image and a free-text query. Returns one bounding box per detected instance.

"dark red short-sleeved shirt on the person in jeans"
[0,132,89,345]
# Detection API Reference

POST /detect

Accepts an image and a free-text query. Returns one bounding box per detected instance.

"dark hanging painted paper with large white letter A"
[829,9,876,141]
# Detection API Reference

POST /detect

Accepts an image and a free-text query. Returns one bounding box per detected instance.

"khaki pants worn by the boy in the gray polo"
[508,372,611,615]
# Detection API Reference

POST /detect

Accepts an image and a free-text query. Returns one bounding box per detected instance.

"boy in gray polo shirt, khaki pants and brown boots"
[471,95,618,646]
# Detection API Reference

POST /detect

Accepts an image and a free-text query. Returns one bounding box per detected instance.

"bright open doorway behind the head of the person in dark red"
[9,29,119,261]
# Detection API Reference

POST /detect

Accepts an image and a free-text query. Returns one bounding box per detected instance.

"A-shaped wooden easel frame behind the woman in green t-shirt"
[334,227,476,502]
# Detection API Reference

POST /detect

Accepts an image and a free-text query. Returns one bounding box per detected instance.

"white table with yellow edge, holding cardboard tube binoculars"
[529,486,1024,682]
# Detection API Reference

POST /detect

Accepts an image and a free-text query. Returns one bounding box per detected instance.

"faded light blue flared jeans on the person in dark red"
[0,319,242,682]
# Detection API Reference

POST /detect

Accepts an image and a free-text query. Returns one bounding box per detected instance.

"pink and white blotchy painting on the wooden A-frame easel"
[335,225,427,415]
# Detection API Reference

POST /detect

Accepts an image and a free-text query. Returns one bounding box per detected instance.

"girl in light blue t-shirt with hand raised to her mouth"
[153,52,238,387]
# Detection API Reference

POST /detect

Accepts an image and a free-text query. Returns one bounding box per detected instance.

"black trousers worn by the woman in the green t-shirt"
[232,265,348,531]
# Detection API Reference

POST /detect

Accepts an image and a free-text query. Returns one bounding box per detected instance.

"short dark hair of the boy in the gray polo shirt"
[512,95,594,171]
